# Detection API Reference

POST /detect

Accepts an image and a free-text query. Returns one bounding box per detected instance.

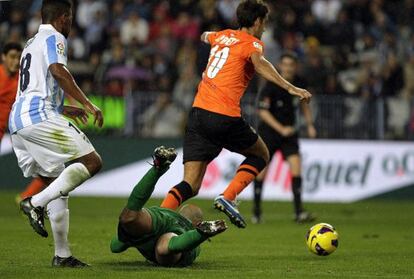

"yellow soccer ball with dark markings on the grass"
[306,223,339,256]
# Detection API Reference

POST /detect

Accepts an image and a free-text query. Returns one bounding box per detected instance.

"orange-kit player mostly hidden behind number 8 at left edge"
[0,42,44,202]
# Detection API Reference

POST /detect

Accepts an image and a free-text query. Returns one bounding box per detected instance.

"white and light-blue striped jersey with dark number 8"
[9,24,67,134]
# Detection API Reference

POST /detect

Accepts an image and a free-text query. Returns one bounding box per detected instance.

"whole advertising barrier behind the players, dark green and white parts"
[0,136,414,202]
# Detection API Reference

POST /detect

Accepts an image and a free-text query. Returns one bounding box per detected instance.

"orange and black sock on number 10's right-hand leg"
[223,156,266,201]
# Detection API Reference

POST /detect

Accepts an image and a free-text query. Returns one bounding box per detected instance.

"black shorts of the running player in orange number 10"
[183,108,259,163]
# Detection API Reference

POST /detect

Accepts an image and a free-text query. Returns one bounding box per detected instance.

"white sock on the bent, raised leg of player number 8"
[31,163,91,207]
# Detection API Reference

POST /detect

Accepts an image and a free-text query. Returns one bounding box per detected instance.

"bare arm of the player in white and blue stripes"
[49,63,103,127]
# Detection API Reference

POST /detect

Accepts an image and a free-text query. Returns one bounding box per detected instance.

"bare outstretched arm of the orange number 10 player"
[251,52,312,102]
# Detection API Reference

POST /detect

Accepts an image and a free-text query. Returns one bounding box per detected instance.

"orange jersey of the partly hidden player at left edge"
[0,65,19,140]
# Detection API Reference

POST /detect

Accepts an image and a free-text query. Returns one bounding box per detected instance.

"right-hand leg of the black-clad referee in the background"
[286,153,315,223]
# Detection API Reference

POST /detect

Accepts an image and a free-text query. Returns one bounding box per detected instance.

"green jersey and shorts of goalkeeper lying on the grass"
[118,206,200,266]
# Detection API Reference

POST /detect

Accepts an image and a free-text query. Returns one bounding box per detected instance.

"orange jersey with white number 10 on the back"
[193,29,264,117]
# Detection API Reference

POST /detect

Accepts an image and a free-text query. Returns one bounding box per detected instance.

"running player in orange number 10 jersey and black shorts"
[161,0,311,228]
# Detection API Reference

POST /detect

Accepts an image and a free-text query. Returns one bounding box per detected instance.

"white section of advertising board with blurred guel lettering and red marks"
[64,140,414,202]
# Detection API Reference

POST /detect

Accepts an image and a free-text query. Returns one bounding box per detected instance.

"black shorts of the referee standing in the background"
[259,127,299,159]
